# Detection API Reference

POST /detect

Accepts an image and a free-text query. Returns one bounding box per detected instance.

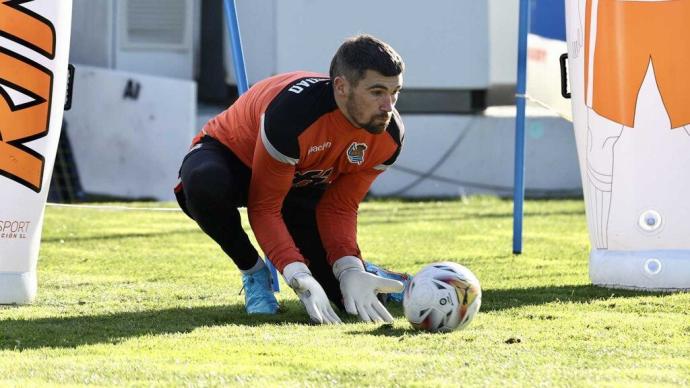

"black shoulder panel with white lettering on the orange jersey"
[264,77,337,159]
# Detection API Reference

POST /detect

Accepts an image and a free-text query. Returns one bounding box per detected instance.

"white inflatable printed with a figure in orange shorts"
[566,0,690,290]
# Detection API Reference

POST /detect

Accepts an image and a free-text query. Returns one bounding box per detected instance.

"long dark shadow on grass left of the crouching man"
[0,301,311,350]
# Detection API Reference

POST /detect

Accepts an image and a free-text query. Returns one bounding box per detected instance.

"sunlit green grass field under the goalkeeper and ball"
[0,197,690,387]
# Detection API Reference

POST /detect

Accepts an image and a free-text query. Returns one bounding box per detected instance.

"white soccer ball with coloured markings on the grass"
[403,261,482,332]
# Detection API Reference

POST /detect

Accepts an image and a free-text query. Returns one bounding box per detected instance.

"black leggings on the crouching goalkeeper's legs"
[176,136,342,308]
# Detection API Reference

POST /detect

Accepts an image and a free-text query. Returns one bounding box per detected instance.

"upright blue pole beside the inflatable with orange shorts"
[513,0,529,254]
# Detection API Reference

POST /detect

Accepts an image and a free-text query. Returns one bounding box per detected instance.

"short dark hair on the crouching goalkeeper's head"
[329,34,405,85]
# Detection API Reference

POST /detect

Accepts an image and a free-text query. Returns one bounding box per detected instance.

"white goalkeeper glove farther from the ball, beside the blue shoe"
[283,261,342,324]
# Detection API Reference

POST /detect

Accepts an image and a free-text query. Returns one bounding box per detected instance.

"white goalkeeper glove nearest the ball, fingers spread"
[333,256,404,323]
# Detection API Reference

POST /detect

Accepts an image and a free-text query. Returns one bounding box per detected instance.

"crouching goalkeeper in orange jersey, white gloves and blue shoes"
[175,35,409,324]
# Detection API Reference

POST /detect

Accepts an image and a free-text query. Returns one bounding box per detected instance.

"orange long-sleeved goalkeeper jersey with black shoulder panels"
[202,72,404,271]
